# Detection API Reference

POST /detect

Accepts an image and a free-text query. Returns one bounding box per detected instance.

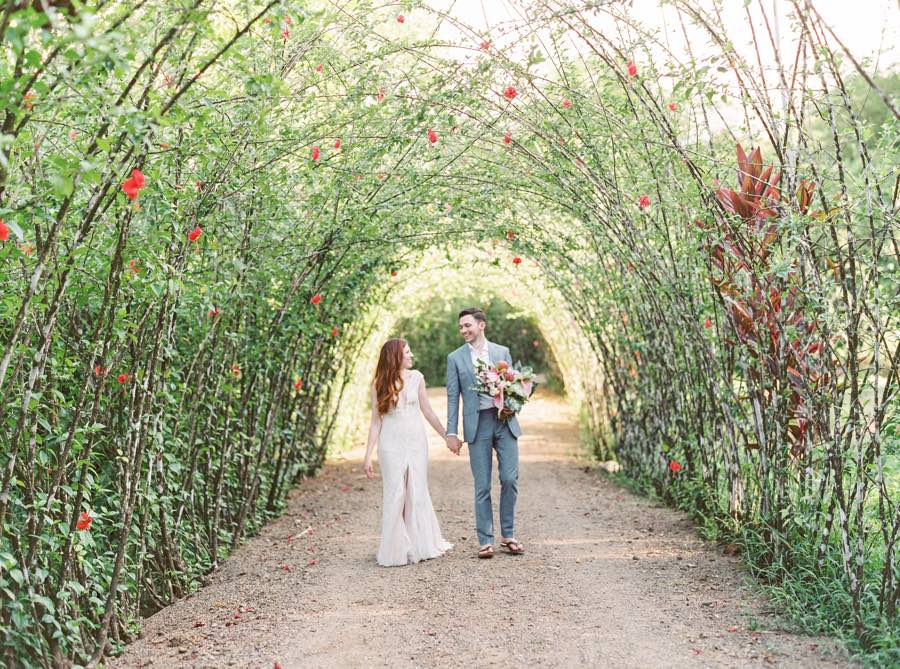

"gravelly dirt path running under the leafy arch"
[109,391,847,669]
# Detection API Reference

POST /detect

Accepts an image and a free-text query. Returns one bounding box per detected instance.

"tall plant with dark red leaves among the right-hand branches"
[697,144,828,457]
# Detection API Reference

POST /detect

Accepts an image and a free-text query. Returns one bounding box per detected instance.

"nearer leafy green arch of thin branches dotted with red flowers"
[0,0,900,664]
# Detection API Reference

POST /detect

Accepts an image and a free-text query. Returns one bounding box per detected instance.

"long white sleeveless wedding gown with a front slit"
[378,370,453,567]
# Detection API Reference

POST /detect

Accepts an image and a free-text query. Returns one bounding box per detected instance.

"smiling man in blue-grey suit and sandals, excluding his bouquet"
[447,307,525,558]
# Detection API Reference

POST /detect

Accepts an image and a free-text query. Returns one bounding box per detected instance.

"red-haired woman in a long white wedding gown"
[363,339,453,567]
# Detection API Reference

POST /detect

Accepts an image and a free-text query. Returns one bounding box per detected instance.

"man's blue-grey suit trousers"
[469,409,519,546]
